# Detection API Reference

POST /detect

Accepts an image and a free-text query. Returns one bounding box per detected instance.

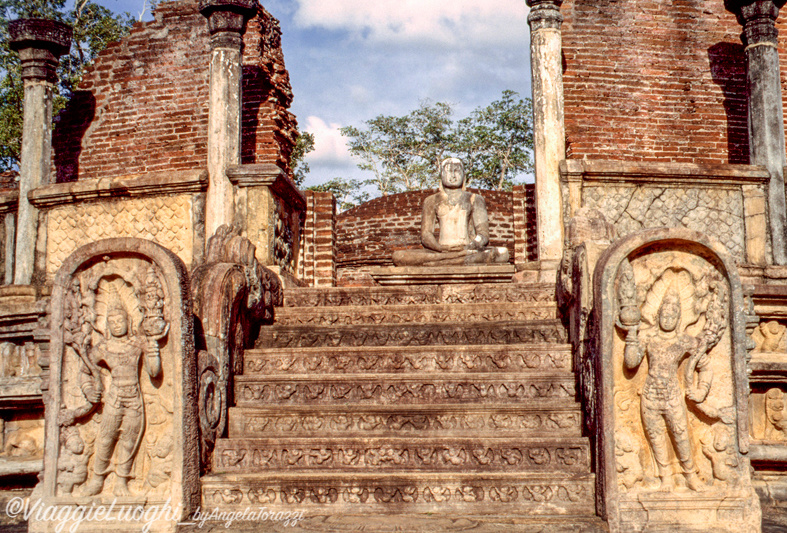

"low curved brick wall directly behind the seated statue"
[336,185,535,285]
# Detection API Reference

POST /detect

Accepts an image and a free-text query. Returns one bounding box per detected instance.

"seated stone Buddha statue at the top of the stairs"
[393,158,508,266]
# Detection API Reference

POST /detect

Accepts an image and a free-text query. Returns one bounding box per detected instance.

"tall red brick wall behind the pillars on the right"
[561,0,787,164]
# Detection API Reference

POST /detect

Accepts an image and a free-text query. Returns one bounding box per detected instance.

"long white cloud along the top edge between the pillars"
[295,0,529,47]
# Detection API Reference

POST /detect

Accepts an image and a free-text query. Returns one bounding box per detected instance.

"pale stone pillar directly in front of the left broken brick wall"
[199,0,255,241]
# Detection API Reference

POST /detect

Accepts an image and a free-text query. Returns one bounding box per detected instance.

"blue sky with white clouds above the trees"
[86,0,530,185]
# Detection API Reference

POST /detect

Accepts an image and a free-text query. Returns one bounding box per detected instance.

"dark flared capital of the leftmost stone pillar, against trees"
[8,19,72,83]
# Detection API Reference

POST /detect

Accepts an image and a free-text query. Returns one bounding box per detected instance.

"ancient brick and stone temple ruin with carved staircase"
[0,0,787,532]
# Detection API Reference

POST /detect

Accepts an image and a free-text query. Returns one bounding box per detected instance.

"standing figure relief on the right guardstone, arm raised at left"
[618,261,729,491]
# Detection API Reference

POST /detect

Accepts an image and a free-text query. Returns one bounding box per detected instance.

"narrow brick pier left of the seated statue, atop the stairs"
[298,191,336,287]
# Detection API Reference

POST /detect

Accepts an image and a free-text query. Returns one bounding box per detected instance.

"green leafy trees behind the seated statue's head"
[341,91,533,196]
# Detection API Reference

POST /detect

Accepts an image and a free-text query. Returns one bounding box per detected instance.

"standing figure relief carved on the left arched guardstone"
[58,265,171,496]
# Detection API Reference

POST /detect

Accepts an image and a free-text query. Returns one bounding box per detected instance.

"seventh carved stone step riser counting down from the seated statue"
[213,437,590,474]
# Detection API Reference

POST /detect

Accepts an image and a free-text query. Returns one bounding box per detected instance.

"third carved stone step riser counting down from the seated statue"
[255,320,567,348]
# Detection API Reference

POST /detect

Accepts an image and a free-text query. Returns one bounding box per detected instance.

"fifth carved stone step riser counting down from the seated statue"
[235,373,575,407]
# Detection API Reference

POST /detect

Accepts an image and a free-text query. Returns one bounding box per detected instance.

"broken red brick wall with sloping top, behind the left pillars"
[53,0,296,182]
